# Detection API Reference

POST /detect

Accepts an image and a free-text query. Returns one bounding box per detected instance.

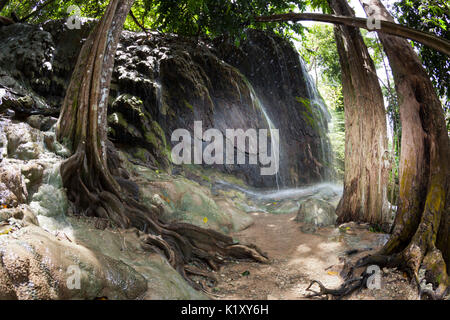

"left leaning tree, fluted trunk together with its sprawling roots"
[57,0,267,287]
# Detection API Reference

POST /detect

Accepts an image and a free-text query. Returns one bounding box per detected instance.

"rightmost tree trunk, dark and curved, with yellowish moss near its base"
[360,0,450,297]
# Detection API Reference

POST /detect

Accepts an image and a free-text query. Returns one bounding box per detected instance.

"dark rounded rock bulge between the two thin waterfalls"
[215,30,331,186]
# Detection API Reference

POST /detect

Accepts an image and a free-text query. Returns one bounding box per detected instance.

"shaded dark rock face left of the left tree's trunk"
[0,21,93,117]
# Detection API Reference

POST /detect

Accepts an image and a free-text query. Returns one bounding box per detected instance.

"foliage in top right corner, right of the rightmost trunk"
[394,0,450,111]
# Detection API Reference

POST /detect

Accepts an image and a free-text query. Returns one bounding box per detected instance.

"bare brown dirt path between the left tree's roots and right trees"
[212,212,418,300]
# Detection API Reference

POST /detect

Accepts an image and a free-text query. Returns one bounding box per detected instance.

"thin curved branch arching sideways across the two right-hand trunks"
[255,13,450,56]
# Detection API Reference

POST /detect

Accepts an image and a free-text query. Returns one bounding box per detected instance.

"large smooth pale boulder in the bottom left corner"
[0,207,206,300]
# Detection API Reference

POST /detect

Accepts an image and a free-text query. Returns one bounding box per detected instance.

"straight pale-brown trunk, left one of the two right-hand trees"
[329,0,388,228]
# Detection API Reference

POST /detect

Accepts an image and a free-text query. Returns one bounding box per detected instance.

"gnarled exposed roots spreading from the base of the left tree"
[61,144,269,290]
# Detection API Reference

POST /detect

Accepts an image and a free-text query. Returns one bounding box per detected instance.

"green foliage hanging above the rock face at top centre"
[146,0,305,37]
